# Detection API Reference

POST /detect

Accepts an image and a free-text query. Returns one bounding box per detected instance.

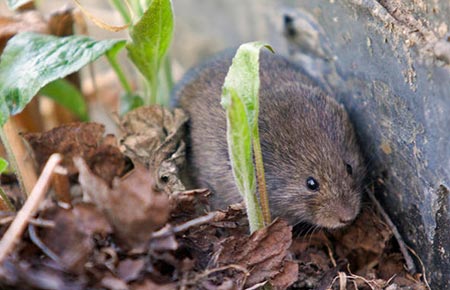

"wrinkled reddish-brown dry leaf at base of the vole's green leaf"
[217,219,297,287]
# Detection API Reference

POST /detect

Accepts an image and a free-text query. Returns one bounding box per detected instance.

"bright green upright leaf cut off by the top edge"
[127,0,173,103]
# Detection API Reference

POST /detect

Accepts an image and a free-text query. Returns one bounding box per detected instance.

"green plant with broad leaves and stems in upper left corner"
[0,0,173,196]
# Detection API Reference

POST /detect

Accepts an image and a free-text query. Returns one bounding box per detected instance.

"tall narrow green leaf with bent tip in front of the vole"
[221,42,271,232]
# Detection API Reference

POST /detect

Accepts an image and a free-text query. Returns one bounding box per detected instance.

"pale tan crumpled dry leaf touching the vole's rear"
[121,105,188,194]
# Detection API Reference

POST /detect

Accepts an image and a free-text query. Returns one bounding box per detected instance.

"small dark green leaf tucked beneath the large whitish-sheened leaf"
[39,79,89,121]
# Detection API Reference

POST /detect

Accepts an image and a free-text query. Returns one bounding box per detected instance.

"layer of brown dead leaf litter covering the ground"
[0,106,426,290]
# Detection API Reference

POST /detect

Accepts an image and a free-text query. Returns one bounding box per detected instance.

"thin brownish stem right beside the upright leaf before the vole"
[252,130,272,226]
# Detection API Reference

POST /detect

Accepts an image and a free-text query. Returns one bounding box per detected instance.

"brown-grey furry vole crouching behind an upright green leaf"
[175,53,362,228]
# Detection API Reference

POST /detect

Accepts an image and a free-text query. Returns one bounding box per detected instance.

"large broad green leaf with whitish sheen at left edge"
[0,32,125,125]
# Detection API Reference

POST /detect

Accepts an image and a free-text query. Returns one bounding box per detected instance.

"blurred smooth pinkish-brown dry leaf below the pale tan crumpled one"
[74,157,170,248]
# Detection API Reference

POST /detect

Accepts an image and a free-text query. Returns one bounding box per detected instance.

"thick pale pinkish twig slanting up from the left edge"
[0,154,62,263]
